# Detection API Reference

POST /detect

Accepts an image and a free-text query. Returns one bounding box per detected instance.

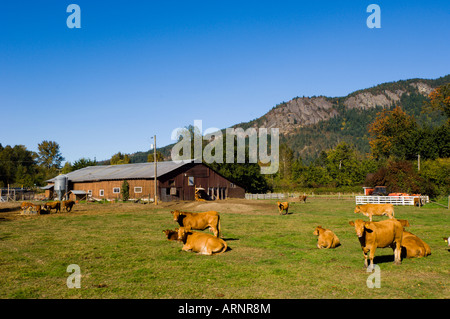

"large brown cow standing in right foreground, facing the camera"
[349,219,403,269]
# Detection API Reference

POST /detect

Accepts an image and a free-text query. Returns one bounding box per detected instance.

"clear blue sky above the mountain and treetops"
[0,0,450,162]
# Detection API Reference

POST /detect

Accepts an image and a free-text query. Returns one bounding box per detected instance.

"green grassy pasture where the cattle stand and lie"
[0,198,450,299]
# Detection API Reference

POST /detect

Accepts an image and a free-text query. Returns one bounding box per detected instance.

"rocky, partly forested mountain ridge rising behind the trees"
[131,74,450,163]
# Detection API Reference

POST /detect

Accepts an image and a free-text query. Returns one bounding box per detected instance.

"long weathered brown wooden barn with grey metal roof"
[44,161,245,202]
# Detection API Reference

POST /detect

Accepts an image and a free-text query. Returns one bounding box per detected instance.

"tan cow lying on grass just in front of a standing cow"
[178,227,228,256]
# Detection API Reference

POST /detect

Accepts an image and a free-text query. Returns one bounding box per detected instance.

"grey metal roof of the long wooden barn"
[47,161,192,182]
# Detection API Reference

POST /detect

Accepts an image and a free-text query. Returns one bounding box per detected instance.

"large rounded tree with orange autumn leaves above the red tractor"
[369,106,418,159]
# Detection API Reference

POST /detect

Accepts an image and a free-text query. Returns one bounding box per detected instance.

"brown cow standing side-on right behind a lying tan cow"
[171,210,220,237]
